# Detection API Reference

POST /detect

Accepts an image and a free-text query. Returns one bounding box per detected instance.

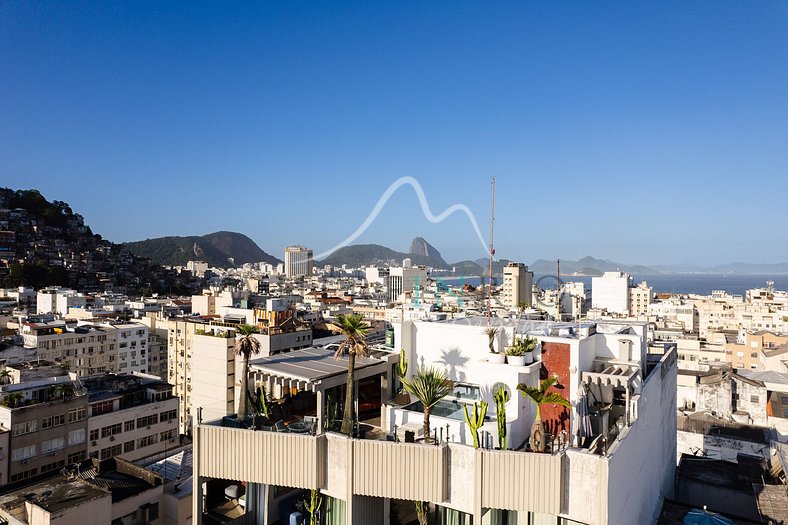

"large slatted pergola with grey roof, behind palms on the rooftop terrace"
[249,347,399,428]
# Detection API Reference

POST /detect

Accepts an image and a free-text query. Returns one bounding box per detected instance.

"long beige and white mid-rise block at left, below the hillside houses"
[20,320,148,377]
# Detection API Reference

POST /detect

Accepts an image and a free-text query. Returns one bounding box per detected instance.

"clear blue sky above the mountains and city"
[0,0,788,264]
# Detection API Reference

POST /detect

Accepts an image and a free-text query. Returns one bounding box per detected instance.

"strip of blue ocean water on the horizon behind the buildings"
[441,273,788,295]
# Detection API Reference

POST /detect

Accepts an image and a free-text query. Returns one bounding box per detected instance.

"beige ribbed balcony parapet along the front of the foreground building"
[194,421,565,515]
